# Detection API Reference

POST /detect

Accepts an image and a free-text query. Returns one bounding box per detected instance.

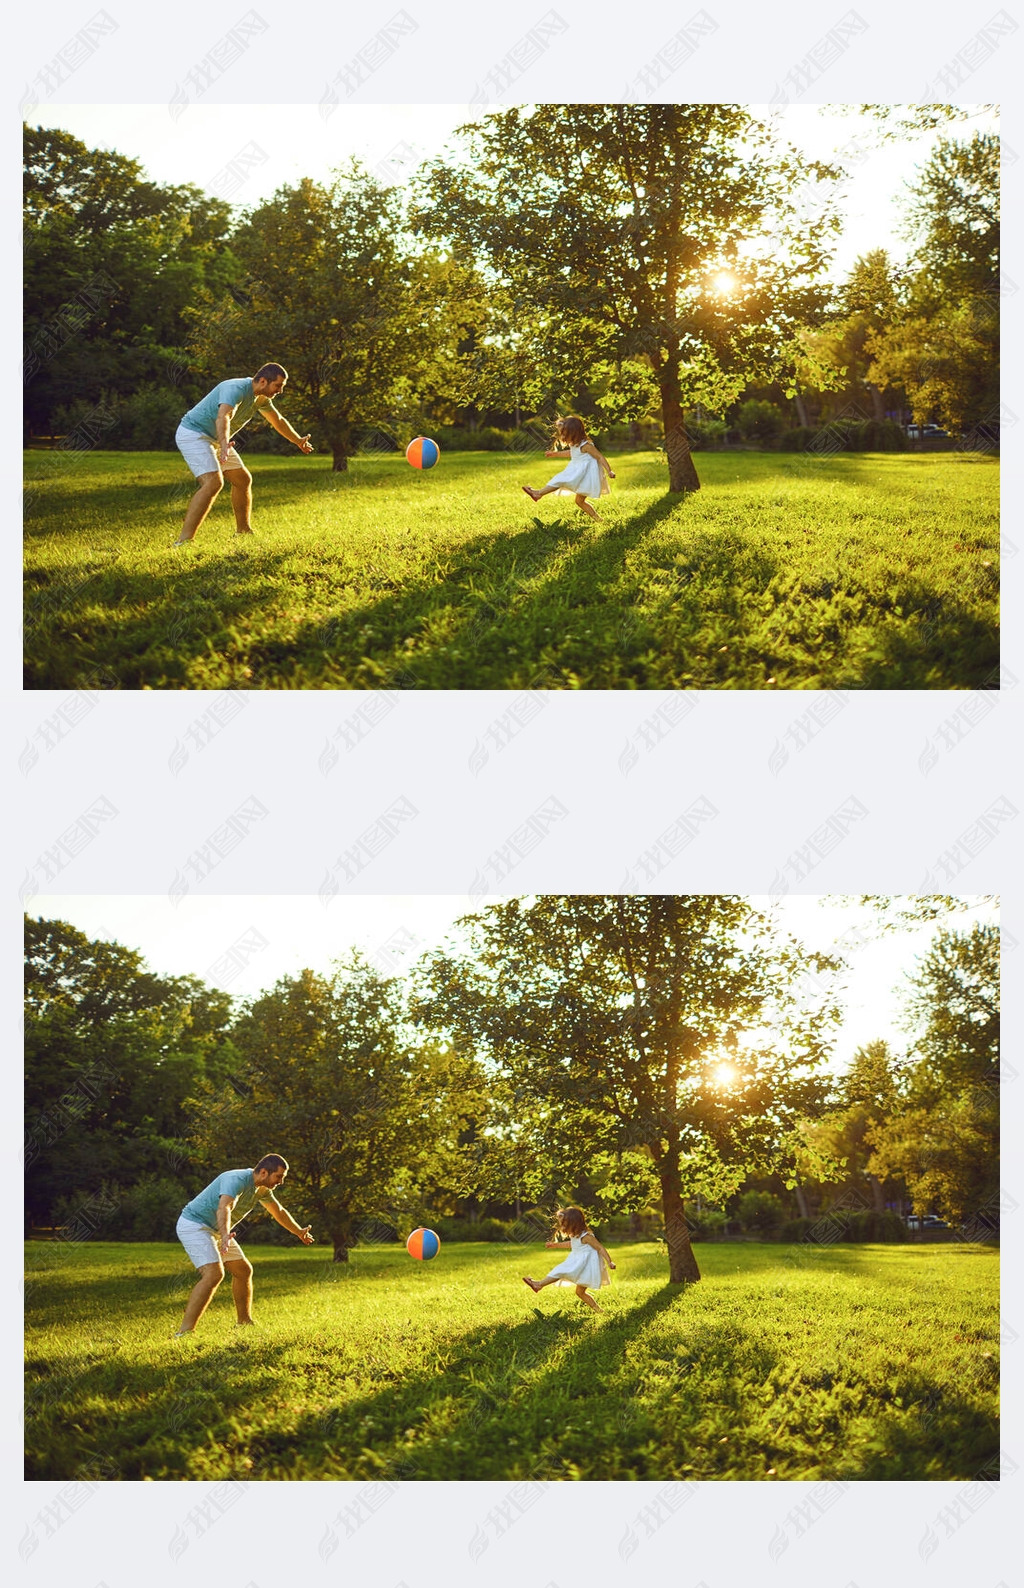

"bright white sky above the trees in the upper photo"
[40,105,999,279]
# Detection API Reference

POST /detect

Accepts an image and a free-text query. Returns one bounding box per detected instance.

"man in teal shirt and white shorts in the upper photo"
[175,364,313,546]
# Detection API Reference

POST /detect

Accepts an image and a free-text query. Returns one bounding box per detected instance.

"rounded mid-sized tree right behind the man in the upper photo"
[192,173,462,470]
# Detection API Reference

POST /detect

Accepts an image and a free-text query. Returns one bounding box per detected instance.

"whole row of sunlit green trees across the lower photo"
[25,897,999,1259]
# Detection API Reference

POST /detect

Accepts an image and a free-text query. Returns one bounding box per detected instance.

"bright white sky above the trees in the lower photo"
[32,894,997,1064]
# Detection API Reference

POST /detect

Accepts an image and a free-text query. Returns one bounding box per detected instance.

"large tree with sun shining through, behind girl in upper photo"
[418,105,838,491]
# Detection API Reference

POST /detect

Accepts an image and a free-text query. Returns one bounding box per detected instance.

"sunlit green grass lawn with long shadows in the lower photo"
[27,1243,999,1482]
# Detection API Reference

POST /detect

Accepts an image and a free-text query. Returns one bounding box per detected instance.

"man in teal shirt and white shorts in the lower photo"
[175,1153,313,1339]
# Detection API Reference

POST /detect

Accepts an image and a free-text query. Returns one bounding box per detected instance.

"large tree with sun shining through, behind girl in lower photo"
[414,896,837,1283]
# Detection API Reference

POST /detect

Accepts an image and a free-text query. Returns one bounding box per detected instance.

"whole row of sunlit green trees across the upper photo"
[24,106,999,463]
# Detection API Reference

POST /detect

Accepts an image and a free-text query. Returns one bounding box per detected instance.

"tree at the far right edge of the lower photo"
[870,923,999,1226]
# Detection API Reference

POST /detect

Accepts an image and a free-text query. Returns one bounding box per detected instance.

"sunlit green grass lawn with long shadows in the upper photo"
[25,453,999,689]
